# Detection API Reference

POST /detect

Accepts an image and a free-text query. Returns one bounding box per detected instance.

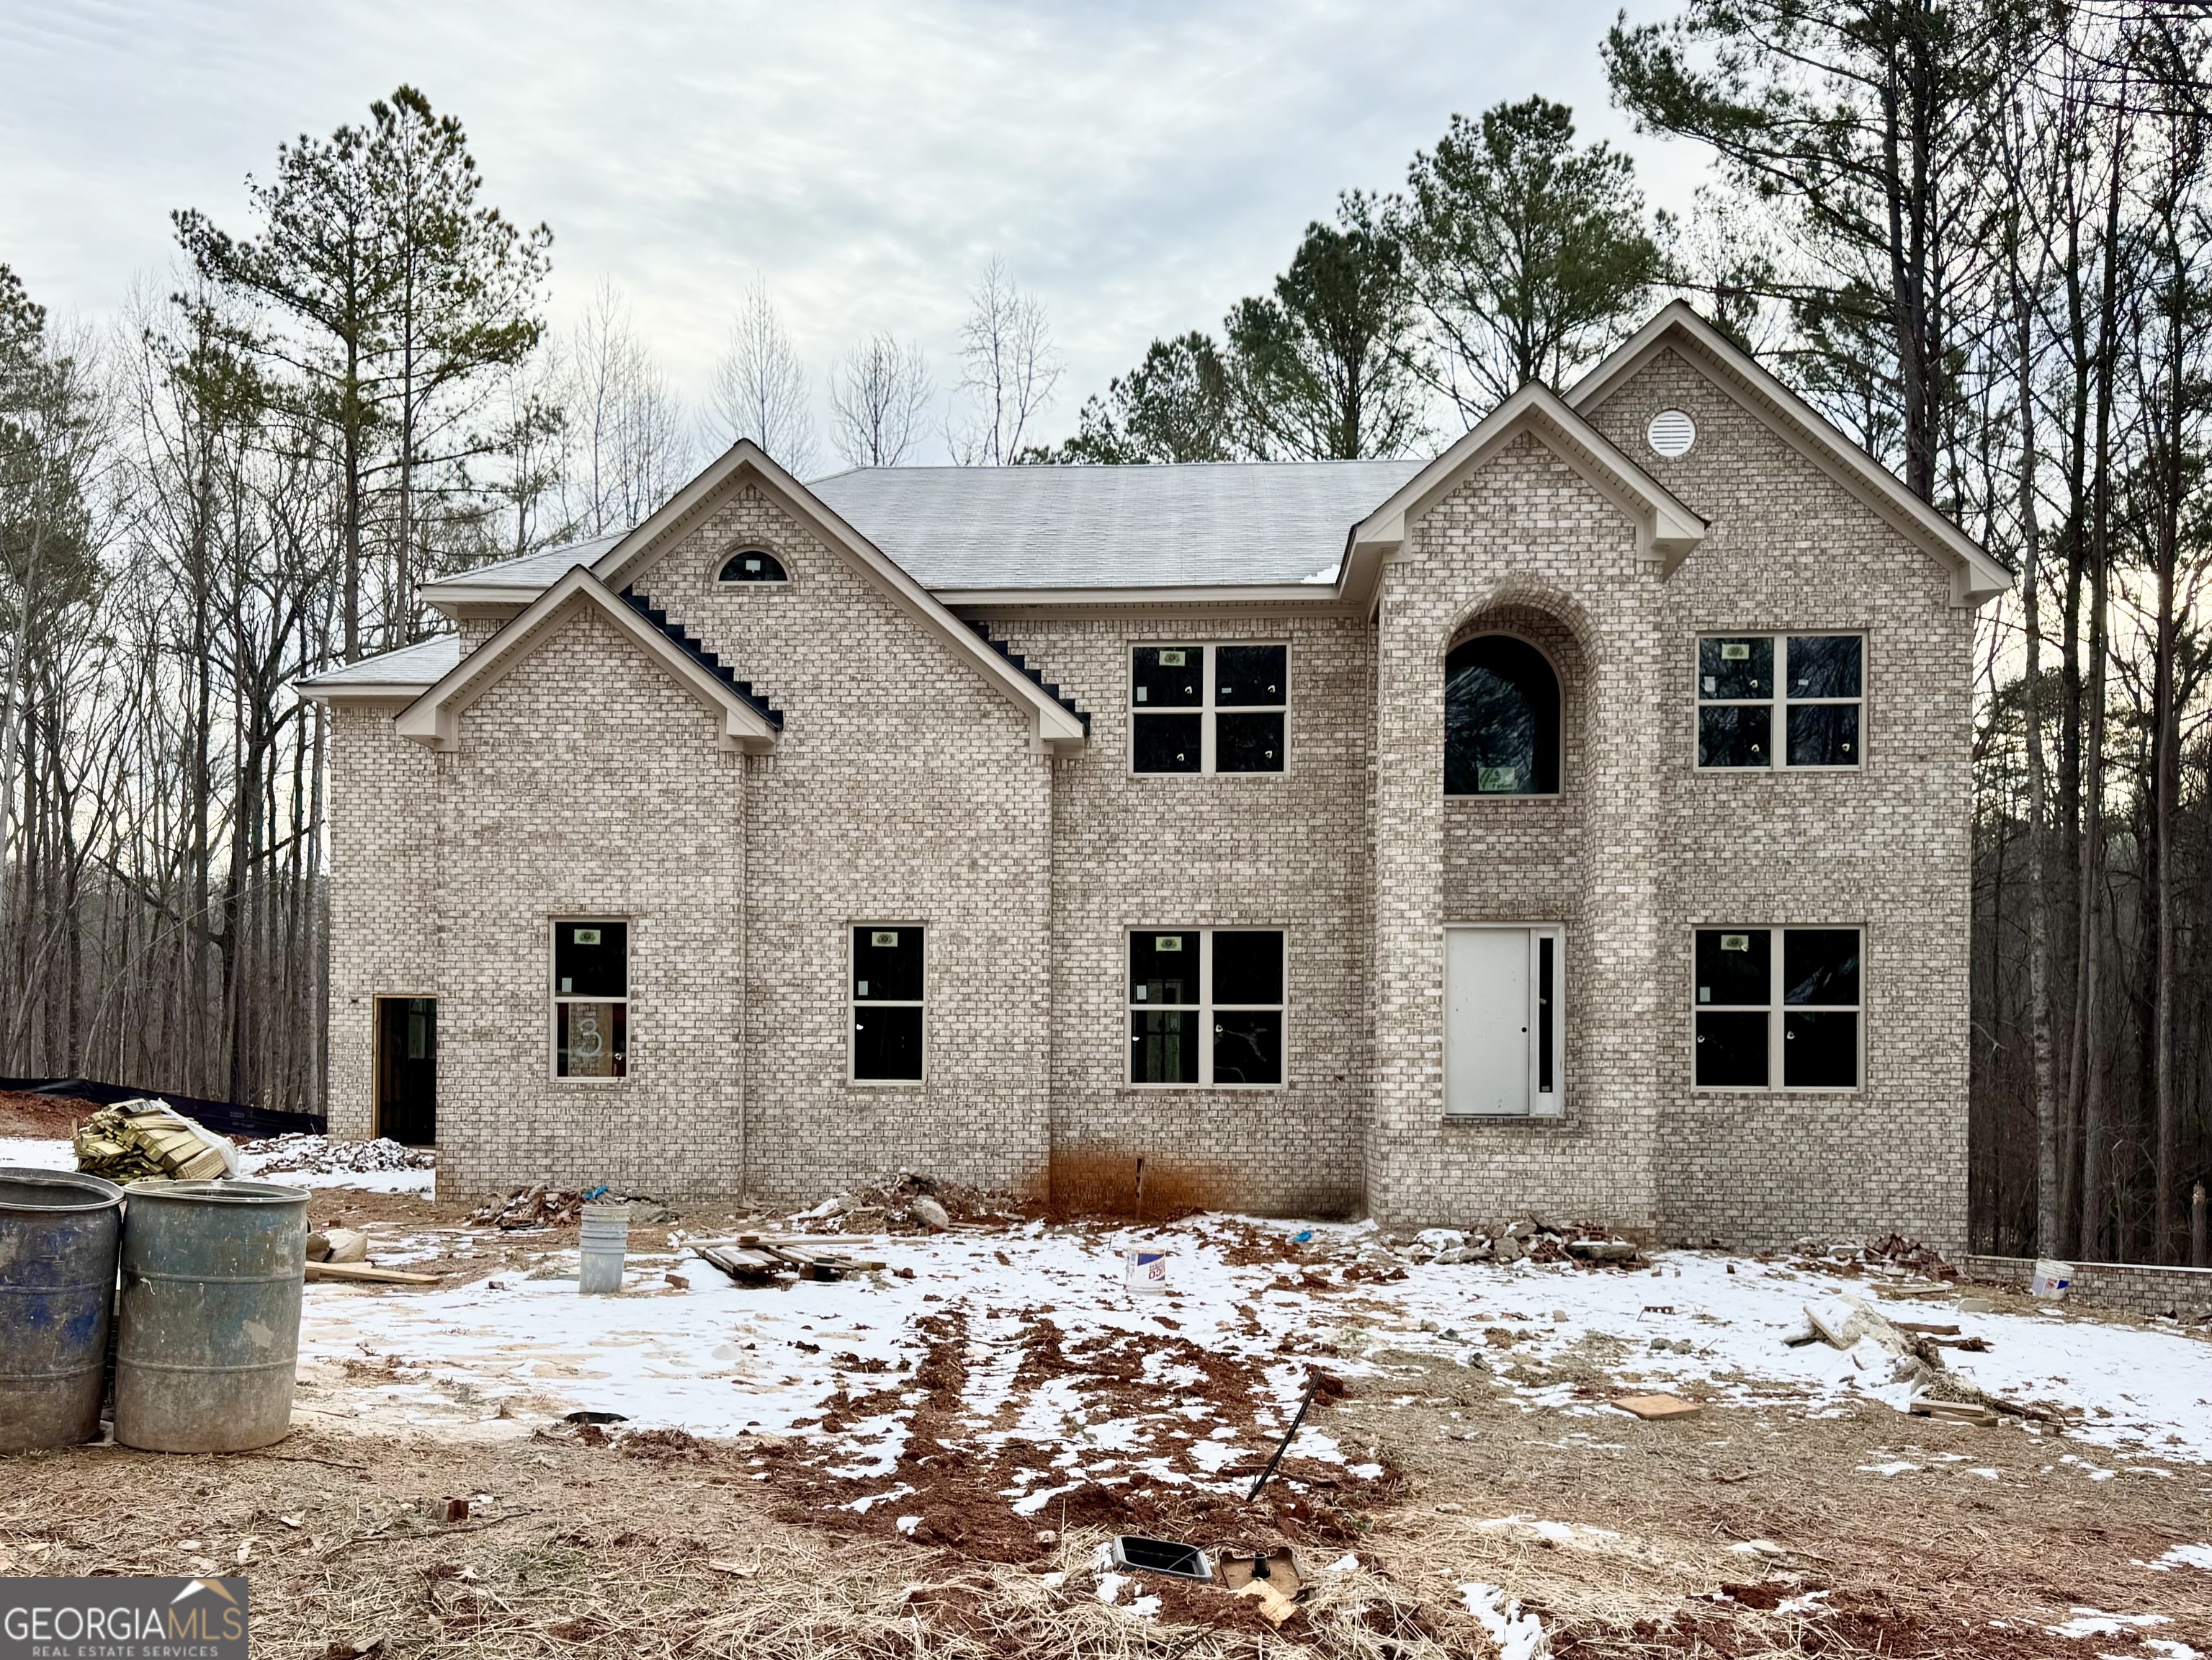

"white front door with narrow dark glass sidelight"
[1444,927,1562,1117]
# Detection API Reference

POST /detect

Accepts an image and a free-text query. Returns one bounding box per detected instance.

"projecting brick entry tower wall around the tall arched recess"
[1367,436,1659,1228]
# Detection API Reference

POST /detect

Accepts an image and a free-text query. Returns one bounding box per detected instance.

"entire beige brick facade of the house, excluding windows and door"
[332,352,1971,1249]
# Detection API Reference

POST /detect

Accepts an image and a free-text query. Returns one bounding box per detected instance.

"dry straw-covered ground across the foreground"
[0,1355,2212,1660]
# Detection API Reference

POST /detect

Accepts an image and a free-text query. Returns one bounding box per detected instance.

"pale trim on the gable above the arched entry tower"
[1336,385,1708,609]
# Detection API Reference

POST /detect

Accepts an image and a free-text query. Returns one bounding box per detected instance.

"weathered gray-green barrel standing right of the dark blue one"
[115,1182,308,1452]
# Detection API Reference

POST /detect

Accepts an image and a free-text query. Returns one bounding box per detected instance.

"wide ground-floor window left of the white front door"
[1128,927,1283,1086]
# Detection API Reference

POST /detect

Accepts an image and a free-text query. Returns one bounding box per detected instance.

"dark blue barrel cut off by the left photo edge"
[0,1166,124,1452]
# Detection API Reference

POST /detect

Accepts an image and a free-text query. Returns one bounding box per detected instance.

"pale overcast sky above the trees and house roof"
[0,0,1701,463]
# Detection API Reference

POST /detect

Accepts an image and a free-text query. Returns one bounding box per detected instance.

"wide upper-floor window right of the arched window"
[1696,633,1867,768]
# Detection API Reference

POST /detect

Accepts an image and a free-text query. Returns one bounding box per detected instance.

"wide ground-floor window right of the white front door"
[1696,927,1863,1089]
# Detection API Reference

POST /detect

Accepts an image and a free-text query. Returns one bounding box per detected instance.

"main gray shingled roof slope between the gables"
[807,460,1425,589]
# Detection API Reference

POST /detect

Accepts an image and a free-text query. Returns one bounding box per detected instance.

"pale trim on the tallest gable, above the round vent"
[1566,299,2013,607]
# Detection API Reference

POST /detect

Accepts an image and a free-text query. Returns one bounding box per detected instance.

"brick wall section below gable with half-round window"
[635,487,1053,1197]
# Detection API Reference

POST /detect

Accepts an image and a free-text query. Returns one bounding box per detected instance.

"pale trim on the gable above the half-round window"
[591,438,1084,755]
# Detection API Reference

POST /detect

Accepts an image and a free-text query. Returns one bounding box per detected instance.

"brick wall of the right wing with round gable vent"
[1595,352,1973,1251]
